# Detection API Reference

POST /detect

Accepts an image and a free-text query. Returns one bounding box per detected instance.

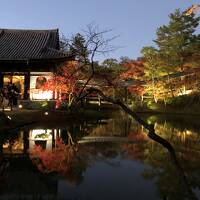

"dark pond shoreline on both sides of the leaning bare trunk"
[0,109,200,132]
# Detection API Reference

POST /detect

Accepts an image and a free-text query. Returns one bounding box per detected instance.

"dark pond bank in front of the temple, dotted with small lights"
[0,109,111,132]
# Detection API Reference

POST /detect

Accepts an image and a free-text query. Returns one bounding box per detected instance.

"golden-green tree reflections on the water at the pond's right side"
[138,116,200,199]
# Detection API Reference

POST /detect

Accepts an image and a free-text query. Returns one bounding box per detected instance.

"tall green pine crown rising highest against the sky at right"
[155,9,200,73]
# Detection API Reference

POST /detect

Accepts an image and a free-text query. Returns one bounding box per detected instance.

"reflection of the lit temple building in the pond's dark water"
[0,129,65,199]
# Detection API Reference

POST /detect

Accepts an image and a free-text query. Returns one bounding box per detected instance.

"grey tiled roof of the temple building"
[0,29,67,60]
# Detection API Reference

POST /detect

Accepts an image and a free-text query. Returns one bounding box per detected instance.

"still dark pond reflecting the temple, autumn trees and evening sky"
[0,111,200,200]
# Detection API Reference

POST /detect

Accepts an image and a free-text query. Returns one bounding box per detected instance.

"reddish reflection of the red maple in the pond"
[30,138,87,186]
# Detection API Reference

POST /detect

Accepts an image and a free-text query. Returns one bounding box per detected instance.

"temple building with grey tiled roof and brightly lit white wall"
[0,29,70,99]
